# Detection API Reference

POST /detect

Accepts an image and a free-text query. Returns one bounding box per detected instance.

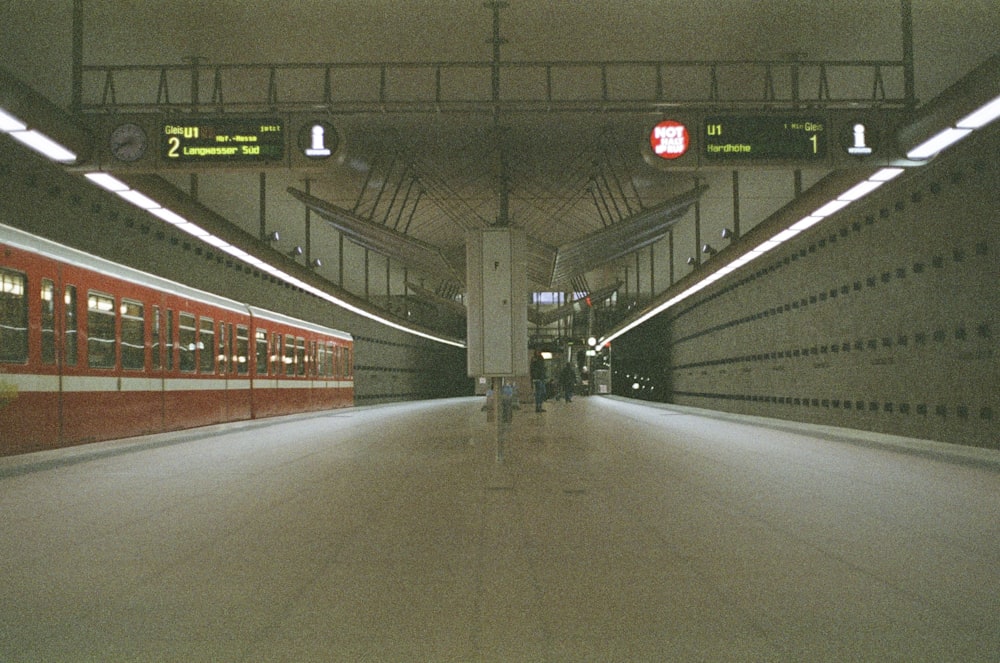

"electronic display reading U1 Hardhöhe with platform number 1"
[702,115,829,161]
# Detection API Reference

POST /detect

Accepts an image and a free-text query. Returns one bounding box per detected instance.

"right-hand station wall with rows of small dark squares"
[668,142,1000,447]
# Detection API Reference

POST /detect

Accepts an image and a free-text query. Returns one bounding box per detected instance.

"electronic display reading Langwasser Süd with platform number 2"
[160,118,285,163]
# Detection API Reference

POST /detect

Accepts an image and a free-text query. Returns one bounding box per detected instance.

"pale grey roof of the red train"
[0,223,353,341]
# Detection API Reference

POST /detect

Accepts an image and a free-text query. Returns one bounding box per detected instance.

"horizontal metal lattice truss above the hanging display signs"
[81,58,913,113]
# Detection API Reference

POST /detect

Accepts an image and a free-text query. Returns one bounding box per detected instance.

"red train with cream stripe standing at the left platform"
[0,224,354,455]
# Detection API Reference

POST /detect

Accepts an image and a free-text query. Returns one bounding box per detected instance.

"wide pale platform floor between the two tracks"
[0,398,1000,662]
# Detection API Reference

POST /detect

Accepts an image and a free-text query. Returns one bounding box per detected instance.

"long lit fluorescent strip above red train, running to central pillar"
[85,172,465,348]
